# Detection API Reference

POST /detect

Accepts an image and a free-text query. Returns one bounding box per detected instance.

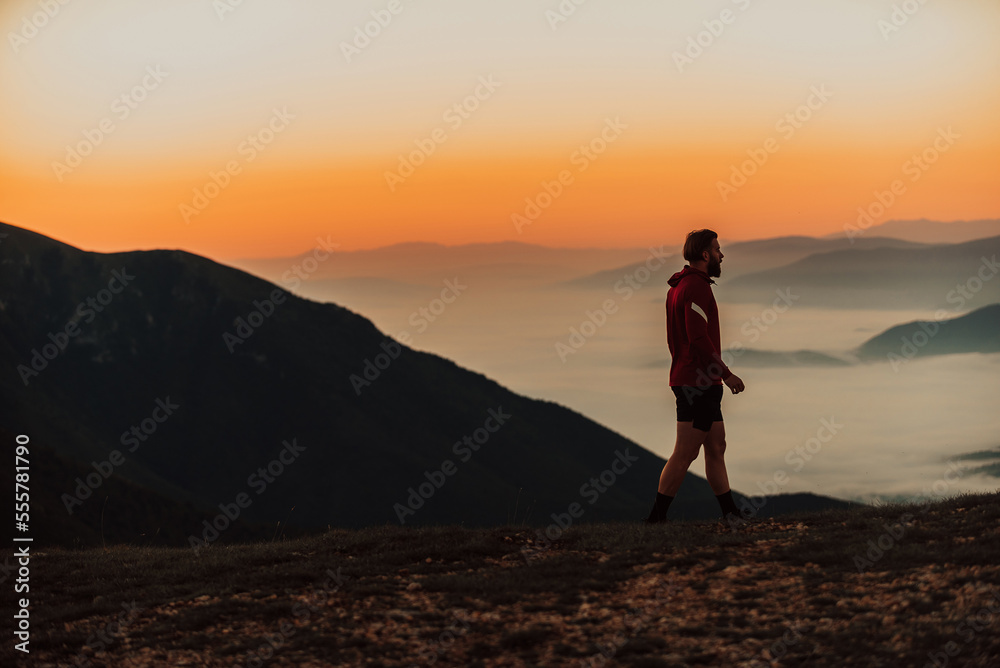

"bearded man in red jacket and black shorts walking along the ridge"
[646,230,744,524]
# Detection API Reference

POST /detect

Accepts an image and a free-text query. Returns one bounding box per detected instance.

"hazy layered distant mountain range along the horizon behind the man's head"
[227,220,1000,315]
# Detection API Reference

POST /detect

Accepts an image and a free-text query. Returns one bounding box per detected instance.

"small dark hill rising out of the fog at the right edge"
[857,302,1000,360]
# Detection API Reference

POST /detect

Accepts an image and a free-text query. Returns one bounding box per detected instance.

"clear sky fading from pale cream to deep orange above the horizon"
[0,0,1000,259]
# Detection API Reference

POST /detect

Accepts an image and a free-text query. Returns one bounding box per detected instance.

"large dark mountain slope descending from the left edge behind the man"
[0,224,860,533]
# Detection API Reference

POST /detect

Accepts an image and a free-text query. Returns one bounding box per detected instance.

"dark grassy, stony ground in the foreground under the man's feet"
[0,494,1000,668]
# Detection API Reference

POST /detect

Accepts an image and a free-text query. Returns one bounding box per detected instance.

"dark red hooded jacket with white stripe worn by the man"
[667,265,733,387]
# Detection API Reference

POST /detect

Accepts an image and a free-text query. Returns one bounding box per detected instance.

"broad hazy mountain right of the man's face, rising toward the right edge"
[716,236,1000,310]
